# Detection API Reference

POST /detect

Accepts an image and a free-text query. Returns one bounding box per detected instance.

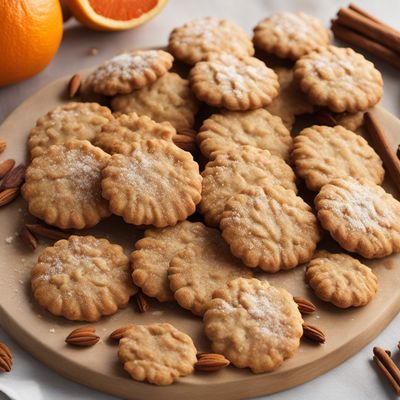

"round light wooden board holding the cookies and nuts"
[0,69,400,400]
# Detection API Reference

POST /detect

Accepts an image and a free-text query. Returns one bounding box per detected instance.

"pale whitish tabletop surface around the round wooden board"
[0,0,400,400]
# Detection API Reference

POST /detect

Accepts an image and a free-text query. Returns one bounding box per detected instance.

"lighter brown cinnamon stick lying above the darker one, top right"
[338,8,400,52]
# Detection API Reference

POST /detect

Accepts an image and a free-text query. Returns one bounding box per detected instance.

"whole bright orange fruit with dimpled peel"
[0,0,63,86]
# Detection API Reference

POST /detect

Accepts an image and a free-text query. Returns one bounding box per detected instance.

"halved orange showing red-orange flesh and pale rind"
[66,0,168,31]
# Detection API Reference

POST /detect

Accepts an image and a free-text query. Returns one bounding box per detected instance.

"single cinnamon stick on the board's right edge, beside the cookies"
[364,111,400,190]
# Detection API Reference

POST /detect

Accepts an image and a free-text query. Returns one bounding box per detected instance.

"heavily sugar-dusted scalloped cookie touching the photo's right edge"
[315,178,400,258]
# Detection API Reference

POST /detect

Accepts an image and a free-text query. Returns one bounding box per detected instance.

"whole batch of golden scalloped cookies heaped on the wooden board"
[19,13,400,384]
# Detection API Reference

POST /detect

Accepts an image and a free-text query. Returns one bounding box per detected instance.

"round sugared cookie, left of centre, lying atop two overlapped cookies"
[101,139,202,228]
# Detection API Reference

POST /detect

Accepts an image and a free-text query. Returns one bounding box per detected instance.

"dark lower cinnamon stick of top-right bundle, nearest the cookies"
[331,20,400,68]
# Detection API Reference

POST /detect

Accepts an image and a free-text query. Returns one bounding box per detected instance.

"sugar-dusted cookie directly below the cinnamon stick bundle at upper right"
[294,46,383,113]
